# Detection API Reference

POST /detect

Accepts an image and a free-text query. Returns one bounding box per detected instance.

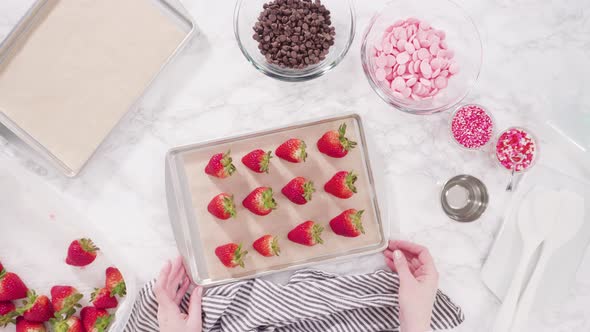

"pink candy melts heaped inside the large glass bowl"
[371,18,459,100]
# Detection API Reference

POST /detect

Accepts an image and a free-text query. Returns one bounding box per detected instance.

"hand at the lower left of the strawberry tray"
[154,257,203,332]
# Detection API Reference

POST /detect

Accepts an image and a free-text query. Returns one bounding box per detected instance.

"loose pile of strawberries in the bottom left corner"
[0,238,127,332]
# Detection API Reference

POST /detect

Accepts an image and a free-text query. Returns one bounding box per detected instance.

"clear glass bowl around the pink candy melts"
[361,0,482,114]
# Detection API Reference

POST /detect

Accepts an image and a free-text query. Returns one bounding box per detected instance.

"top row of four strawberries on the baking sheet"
[205,123,357,179]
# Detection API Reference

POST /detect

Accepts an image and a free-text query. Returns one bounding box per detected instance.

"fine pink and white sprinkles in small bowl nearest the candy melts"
[451,105,494,149]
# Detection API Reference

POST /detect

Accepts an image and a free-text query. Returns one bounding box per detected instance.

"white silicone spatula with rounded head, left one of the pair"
[493,188,558,332]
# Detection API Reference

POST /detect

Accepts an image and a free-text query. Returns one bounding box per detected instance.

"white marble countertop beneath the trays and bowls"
[0,0,590,331]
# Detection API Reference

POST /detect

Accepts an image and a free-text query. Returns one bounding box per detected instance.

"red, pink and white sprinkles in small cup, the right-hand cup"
[496,128,537,172]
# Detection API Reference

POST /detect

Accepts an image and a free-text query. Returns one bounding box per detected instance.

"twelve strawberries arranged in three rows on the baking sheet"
[205,124,365,267]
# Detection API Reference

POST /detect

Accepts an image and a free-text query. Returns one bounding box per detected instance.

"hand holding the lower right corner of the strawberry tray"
[383,241,438,332]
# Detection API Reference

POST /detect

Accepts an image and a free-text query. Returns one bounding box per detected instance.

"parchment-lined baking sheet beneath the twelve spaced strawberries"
[169,116,385,285]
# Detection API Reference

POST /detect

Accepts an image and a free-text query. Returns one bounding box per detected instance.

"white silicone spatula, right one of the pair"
[512,191,584,332]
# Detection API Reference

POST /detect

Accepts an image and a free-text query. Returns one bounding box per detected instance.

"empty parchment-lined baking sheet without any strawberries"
[0,0,193,175]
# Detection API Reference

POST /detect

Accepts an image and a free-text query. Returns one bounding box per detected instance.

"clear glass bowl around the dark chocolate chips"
[234,0,356,82]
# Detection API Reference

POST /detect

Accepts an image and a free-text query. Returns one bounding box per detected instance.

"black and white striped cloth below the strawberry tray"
[125,270,464,332]
